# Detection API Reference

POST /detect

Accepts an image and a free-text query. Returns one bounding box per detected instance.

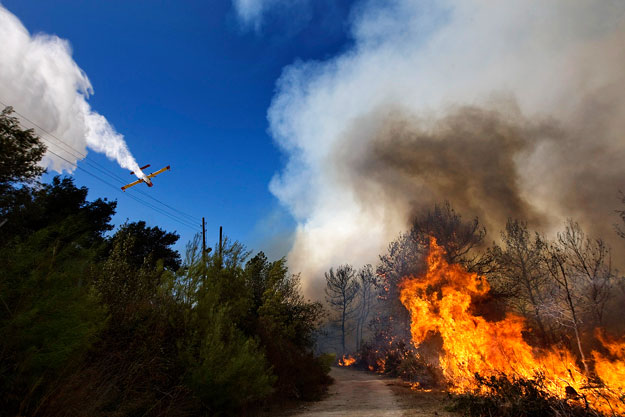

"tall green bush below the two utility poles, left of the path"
[173,239,275,414]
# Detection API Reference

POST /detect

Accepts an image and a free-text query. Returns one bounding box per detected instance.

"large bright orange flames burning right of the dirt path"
[400,238,625,413]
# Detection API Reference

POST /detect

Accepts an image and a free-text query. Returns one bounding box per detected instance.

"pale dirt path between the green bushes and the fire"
[289,368,452,417]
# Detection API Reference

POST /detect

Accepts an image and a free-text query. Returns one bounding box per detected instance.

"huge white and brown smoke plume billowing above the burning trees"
[268,0,625,295]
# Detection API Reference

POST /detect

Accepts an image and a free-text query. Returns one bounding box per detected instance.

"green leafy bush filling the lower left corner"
[0,221,106,411]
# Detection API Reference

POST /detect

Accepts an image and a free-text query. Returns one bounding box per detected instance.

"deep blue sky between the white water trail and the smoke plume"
[2,0,351,257]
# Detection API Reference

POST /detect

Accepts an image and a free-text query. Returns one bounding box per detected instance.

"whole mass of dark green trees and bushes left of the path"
[0,109,329,416]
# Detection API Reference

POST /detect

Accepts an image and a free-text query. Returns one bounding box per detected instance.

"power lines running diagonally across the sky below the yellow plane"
[0,100,197,231]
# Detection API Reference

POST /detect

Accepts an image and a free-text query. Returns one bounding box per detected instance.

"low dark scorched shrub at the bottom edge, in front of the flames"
[450,374,601,417]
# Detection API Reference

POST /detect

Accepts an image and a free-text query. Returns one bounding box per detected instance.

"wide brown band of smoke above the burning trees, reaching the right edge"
[342,101,625,256]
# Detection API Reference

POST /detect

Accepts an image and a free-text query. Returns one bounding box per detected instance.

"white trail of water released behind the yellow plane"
[0,5,140,177]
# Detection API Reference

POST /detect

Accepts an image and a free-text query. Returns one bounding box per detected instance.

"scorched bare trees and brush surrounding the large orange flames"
[327,200,625,416]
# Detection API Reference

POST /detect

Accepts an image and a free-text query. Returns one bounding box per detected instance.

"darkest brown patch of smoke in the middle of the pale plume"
[342,103,561,234]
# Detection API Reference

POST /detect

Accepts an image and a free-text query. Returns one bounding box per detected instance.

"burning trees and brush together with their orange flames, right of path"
[322,197,625,415]
